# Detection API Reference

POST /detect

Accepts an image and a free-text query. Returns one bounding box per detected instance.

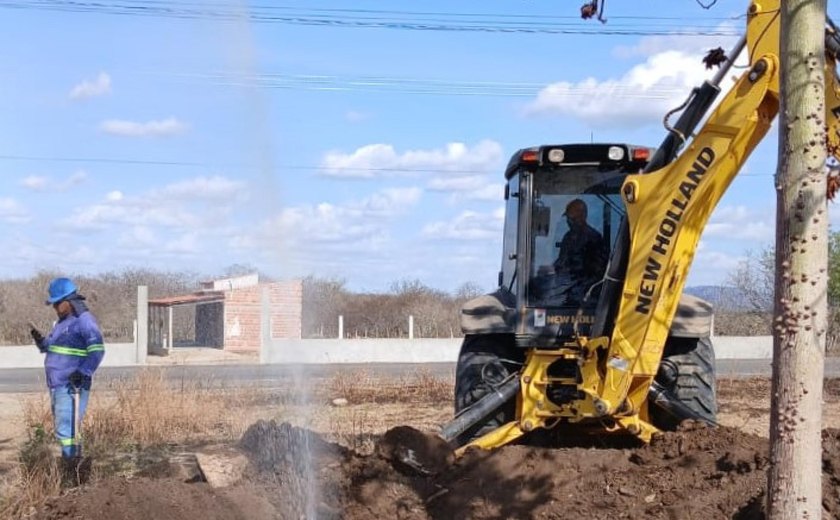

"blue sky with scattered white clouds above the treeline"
[0,0,840,291]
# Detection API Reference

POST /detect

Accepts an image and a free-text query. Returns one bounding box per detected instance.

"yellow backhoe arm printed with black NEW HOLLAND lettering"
[583,1,840,424]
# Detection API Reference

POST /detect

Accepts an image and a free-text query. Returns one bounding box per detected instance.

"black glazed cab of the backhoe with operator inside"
[499,144,654,345]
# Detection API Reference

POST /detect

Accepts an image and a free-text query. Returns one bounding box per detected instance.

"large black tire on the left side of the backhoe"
[455,334,525,445]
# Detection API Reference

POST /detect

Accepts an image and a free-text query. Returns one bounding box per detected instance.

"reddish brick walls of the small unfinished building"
[224,280,303,352]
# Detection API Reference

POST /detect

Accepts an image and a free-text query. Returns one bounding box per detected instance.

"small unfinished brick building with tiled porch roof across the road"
[149,274,303,354]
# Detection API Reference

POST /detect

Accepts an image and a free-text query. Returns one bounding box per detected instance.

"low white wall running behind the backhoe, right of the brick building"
[260,336,773,364]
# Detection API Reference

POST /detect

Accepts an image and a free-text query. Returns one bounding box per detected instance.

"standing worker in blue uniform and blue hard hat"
[30,278,105,461]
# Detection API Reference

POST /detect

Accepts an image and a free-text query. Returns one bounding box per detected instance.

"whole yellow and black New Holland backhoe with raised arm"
[441,0,840,453]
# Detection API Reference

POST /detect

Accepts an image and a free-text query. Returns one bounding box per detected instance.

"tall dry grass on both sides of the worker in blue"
[0,369,262,518]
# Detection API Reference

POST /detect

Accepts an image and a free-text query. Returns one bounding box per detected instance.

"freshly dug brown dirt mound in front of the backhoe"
[38,421,840,520]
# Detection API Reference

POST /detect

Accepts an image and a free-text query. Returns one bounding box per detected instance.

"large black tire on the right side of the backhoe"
[650,337,717,430]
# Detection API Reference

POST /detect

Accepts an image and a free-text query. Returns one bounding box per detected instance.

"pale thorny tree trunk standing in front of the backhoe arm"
[767,0,828,520]
